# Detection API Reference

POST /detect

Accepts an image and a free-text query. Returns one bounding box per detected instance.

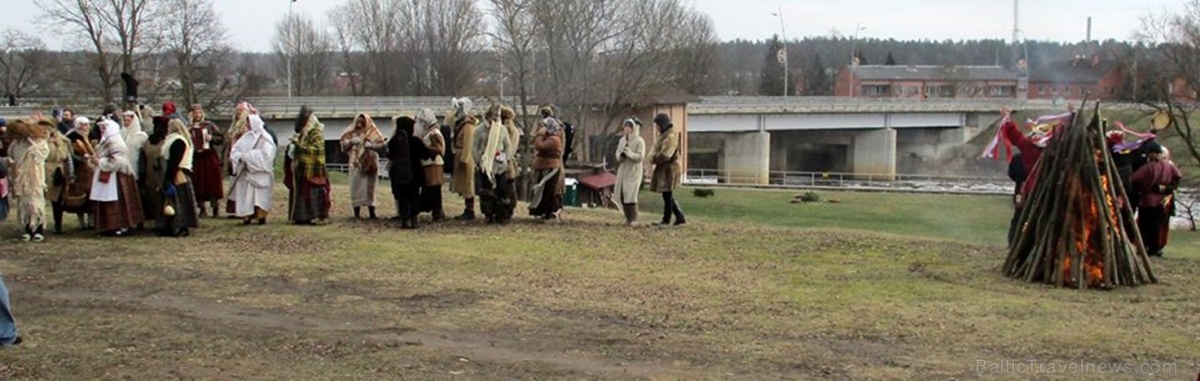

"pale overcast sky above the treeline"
[9,0,1184,52]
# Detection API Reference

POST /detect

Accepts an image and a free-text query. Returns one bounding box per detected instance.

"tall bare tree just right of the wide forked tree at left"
[163,0,246,110]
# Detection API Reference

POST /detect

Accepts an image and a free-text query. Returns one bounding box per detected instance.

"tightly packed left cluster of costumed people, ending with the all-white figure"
[0,102,275,242]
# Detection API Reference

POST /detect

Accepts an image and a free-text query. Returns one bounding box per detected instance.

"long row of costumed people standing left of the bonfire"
[0,98,686,241]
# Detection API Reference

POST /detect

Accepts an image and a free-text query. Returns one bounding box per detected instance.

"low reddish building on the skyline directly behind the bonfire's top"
[1028,55,1126,99]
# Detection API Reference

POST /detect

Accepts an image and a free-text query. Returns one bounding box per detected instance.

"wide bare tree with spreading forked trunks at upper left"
[35,0,162,102]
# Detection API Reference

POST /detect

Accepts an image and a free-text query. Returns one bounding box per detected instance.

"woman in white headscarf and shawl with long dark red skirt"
[90,120,145,236]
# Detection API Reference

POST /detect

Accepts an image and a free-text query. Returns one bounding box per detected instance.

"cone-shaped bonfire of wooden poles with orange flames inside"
[1003,104,1158,289]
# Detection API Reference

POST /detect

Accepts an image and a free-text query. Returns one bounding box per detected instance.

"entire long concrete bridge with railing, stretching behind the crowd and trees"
[0,97,1139,183]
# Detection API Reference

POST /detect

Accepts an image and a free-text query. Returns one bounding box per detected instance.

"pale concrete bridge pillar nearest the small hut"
[721,131,770,185]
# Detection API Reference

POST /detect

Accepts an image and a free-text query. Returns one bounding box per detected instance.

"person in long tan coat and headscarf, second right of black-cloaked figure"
[450,98,479,220]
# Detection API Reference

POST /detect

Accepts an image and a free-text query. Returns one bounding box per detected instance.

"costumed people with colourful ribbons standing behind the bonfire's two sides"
[984,107,1183,256]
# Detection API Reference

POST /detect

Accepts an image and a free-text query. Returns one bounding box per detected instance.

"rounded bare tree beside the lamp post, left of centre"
[272,13,334,96]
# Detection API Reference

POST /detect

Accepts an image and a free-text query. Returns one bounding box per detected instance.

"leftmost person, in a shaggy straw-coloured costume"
[6,120,50,242]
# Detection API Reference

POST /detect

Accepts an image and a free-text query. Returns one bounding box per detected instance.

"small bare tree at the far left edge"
[0,29,49,98]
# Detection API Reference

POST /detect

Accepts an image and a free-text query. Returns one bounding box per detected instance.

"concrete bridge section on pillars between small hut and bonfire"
[688,97,1032,183]
